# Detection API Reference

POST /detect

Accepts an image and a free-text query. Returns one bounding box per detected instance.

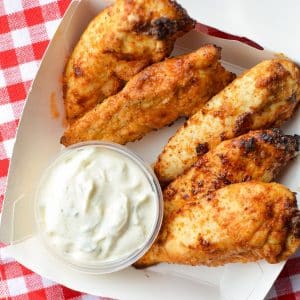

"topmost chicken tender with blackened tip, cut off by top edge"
[63,0,195,122]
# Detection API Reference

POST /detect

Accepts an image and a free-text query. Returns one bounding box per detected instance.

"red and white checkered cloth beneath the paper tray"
[0,0,300,300]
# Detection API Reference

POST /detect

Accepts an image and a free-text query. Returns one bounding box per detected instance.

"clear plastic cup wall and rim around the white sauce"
[34,141,163,274]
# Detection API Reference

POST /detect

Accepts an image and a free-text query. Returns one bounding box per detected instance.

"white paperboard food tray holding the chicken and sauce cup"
[0,0,300,300]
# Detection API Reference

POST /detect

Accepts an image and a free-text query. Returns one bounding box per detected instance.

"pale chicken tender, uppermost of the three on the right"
[155,59,300,183]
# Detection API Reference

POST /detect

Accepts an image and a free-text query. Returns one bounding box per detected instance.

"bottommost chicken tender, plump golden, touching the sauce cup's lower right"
[135,181,300,267]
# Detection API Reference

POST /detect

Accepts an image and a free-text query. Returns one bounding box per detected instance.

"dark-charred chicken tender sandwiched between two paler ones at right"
[163,129,300,219]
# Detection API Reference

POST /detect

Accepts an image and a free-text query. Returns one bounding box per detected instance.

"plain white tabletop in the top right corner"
[178,0,300,62]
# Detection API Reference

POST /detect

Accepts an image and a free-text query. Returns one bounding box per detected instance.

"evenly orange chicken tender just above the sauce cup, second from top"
[61,45,234,146]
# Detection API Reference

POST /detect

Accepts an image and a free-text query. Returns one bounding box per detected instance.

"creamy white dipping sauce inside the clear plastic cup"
[38,146,157,263]
